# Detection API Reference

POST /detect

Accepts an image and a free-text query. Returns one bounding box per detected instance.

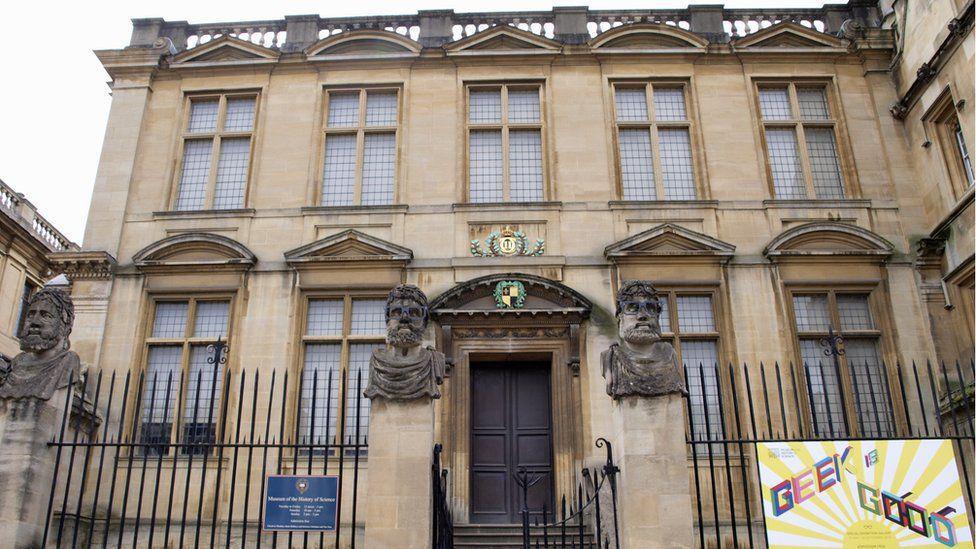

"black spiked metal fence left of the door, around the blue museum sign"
[44,362,369,548]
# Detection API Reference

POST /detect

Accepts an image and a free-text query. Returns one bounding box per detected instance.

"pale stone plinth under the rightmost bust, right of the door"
[612,394,694,549]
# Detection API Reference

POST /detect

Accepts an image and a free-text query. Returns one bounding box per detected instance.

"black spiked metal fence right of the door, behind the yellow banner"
[685,360,976,548]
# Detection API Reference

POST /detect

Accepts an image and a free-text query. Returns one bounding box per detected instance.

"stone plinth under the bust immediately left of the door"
[366,398,434,549]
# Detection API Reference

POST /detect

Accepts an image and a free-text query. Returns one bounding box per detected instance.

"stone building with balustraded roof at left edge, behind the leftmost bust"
[0,181,78,359]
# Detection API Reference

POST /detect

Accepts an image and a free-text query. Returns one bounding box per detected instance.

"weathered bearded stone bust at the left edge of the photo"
[0,288,81,400]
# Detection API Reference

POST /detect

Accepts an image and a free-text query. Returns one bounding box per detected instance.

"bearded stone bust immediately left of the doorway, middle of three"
[363,284,444,400]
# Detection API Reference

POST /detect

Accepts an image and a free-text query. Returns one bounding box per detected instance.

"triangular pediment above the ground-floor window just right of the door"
[603,223,735,260]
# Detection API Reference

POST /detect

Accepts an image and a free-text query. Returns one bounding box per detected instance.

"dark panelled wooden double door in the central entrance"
[470,362,553,524]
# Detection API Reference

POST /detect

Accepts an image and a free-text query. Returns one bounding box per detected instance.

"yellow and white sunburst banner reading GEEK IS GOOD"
[756,440,973,549]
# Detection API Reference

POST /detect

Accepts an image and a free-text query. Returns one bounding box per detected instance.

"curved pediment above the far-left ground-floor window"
[132,233,257,269]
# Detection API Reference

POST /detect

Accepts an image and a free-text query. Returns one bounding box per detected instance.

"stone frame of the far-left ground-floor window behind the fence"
[133,292,237,459]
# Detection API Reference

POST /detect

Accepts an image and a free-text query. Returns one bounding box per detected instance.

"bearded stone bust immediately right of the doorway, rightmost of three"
[600,280,688,399]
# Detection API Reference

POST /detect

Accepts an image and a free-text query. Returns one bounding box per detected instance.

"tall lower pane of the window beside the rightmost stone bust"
[678,342,723,440]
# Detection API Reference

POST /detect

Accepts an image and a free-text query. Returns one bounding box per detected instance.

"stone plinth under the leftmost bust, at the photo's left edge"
[0,388,70,549]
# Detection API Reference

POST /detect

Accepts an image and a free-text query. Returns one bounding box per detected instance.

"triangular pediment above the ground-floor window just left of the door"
[285,229,413,266]
